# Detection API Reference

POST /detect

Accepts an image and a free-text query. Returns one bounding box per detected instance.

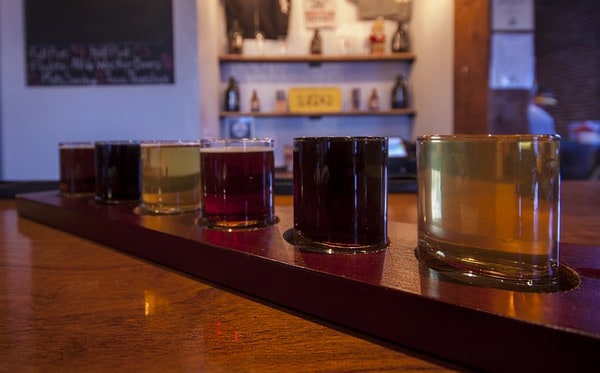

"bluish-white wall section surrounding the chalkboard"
[0,0,201,180]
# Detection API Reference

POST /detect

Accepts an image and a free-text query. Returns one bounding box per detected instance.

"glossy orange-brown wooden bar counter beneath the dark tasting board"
[0,181,600,372]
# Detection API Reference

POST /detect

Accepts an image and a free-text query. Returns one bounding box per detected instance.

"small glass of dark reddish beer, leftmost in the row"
[58,141,96,197]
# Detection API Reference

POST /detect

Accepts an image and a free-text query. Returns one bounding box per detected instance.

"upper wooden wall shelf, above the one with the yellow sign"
[219,52,416,64]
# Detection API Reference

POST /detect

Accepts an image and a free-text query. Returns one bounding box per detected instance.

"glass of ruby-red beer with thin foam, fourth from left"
[199,139,276,230]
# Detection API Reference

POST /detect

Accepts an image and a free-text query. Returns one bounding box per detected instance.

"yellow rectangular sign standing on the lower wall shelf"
[288,87,342,113]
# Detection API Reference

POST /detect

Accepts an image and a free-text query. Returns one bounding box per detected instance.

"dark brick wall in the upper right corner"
[535,0,600,138]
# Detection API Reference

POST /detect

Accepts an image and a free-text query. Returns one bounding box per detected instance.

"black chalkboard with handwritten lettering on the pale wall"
[24,0,175,86]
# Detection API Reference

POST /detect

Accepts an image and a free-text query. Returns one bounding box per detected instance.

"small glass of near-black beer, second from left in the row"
[94,140,140,204]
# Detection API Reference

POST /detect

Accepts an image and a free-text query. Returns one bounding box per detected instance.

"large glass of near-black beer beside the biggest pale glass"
[286,137,388,253]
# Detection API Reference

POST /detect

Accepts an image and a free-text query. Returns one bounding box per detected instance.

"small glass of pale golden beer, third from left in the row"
[141,141,200,214]
